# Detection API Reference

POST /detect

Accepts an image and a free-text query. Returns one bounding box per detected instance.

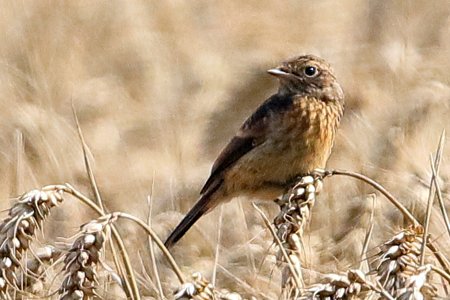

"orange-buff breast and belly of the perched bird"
[225,99,342,192]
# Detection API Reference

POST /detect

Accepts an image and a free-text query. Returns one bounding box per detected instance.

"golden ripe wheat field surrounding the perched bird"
[0,0,450,299]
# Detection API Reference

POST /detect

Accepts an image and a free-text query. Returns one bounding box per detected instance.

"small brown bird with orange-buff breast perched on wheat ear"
[165,55,344,248]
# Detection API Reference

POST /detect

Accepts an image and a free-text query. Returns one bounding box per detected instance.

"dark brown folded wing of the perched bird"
[200,94,292,194]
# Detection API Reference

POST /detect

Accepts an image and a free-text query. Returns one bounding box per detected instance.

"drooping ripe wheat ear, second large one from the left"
[59,214,117,300]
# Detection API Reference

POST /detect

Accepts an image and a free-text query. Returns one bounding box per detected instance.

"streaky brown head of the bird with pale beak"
[267,55,344,101]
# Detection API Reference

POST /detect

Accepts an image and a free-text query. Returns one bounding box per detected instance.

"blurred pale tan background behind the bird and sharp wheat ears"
[0,0,450,297]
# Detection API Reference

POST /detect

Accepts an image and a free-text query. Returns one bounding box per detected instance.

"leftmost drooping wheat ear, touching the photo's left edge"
[0,186,64,298]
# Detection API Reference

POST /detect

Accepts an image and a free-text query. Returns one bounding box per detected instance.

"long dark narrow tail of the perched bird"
[164,182,222,248]
